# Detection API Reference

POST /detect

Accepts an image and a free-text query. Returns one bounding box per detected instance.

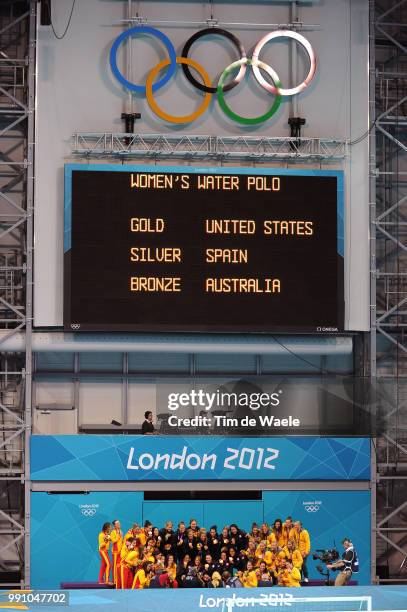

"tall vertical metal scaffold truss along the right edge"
[370,0,407,583]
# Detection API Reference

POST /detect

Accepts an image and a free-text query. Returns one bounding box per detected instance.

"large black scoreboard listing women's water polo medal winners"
[64,164,344,333]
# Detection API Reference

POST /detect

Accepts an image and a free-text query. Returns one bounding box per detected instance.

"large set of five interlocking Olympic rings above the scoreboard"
[110,25,317,125]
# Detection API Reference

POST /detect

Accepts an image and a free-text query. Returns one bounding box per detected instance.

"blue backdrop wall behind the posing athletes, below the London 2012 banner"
[31,490,371,589]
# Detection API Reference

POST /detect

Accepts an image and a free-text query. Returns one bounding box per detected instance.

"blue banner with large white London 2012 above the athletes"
[31,435,370,481]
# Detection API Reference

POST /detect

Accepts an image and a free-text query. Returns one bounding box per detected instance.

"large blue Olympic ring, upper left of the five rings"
[110,25,177,94]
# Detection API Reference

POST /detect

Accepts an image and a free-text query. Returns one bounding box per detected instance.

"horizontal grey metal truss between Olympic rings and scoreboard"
[71,132,349,163]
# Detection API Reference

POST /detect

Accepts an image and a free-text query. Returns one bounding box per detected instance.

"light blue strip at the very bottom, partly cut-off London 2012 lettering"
[0,586,407,612]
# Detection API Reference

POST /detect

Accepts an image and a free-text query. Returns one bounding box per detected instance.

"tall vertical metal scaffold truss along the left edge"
[0,0,37,588]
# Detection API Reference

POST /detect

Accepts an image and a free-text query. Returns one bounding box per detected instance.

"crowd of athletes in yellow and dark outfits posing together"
[99,516,311,589]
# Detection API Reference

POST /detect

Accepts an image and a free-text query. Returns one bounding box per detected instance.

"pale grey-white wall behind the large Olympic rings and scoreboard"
[34,0,369,330]
